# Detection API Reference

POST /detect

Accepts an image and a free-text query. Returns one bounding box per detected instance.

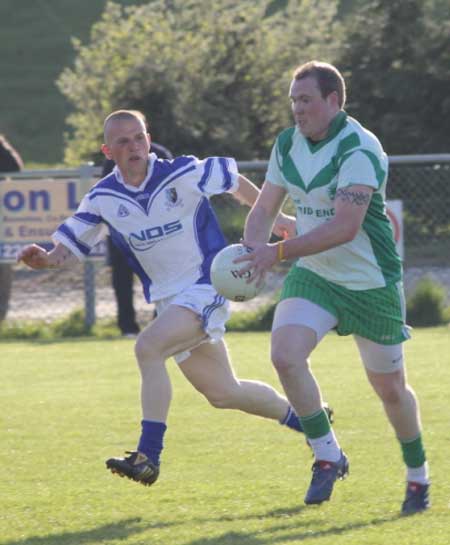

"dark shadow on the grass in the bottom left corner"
[0,518,176,545]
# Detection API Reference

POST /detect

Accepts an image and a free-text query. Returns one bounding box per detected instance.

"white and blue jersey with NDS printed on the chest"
[53,154,239,302]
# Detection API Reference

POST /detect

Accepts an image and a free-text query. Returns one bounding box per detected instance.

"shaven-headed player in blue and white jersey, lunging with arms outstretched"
[18,110,330,485]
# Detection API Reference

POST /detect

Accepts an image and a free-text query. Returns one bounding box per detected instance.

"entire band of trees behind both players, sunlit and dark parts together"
[58,0,450,164]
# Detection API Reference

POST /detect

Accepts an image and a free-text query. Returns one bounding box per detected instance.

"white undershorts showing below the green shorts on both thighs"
[272,297,403,373]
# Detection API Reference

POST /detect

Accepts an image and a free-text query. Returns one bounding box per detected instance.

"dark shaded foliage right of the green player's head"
[338,0,450,154]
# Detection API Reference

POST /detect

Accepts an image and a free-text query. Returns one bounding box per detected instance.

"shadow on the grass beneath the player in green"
[184,506,402,545]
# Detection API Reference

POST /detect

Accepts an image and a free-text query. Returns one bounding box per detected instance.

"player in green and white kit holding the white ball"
[236,61,429,514]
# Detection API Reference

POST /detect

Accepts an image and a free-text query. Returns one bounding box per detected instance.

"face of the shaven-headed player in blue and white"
[102,118,150,178]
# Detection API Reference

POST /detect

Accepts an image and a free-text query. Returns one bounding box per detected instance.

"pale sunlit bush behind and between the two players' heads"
[58,0,338,164]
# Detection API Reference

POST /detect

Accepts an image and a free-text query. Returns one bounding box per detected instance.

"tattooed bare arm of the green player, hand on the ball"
[236,185,373,275]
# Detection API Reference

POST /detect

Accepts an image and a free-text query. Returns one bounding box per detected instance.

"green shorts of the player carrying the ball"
[281,265,410,344]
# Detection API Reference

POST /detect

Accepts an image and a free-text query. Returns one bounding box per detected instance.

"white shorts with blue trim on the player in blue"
[155,284,231,363]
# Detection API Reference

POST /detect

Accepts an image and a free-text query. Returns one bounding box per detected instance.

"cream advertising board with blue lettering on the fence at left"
[0,179,103,261]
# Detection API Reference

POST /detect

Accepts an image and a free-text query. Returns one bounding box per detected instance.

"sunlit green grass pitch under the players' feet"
[0,327,450,545]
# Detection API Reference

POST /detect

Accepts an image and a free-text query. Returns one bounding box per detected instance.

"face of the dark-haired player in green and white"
[289,76,339,141]
